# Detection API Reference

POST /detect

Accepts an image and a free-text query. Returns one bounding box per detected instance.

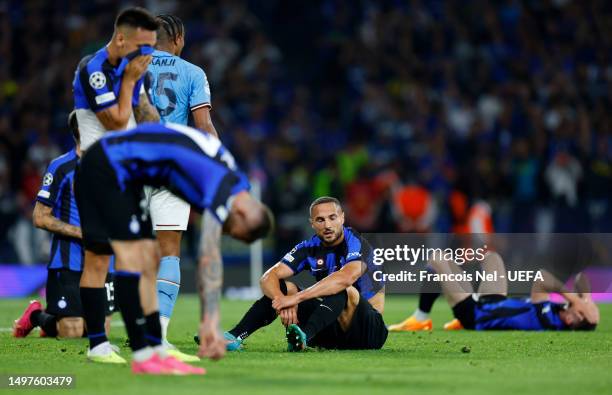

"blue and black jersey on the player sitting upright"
[281,227,384,299]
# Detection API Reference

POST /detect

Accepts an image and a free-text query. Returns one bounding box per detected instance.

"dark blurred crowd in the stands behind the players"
[0,0,612,263]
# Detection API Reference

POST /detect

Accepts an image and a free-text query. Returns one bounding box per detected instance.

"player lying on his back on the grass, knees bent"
[431,252,599,331]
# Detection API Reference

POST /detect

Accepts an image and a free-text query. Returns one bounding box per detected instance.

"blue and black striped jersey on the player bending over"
[100,123,250,222]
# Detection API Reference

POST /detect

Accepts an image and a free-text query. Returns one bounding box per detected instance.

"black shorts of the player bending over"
[74,144,153,255]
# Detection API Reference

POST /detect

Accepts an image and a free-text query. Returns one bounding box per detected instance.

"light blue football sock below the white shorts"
[157,256,181,339]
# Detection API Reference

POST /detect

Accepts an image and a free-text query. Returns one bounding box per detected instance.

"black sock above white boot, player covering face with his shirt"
[80,287,108,350]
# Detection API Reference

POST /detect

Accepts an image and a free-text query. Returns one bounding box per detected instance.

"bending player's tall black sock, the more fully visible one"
[115,271,148,351]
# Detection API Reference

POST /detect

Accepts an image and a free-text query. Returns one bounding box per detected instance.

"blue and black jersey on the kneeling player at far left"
[36,150,83,271]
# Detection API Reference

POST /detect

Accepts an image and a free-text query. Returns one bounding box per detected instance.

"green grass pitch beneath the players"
[0,295,612,395]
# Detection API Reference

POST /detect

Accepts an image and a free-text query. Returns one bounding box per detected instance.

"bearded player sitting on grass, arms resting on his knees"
[225,197,387,351]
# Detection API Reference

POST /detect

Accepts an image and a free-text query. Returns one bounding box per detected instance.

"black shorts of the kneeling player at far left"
[45,269,115,318]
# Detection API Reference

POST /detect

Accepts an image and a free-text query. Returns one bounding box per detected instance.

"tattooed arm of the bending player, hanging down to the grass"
[198,211,225,359]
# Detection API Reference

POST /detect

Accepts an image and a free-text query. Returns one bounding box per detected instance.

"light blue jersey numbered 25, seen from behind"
[148,50,211,125]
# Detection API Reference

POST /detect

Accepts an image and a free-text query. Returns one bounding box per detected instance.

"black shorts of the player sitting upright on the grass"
[298,296,389,350]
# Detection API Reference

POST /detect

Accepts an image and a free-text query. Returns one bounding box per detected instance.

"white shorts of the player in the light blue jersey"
[144,186,190,231]
